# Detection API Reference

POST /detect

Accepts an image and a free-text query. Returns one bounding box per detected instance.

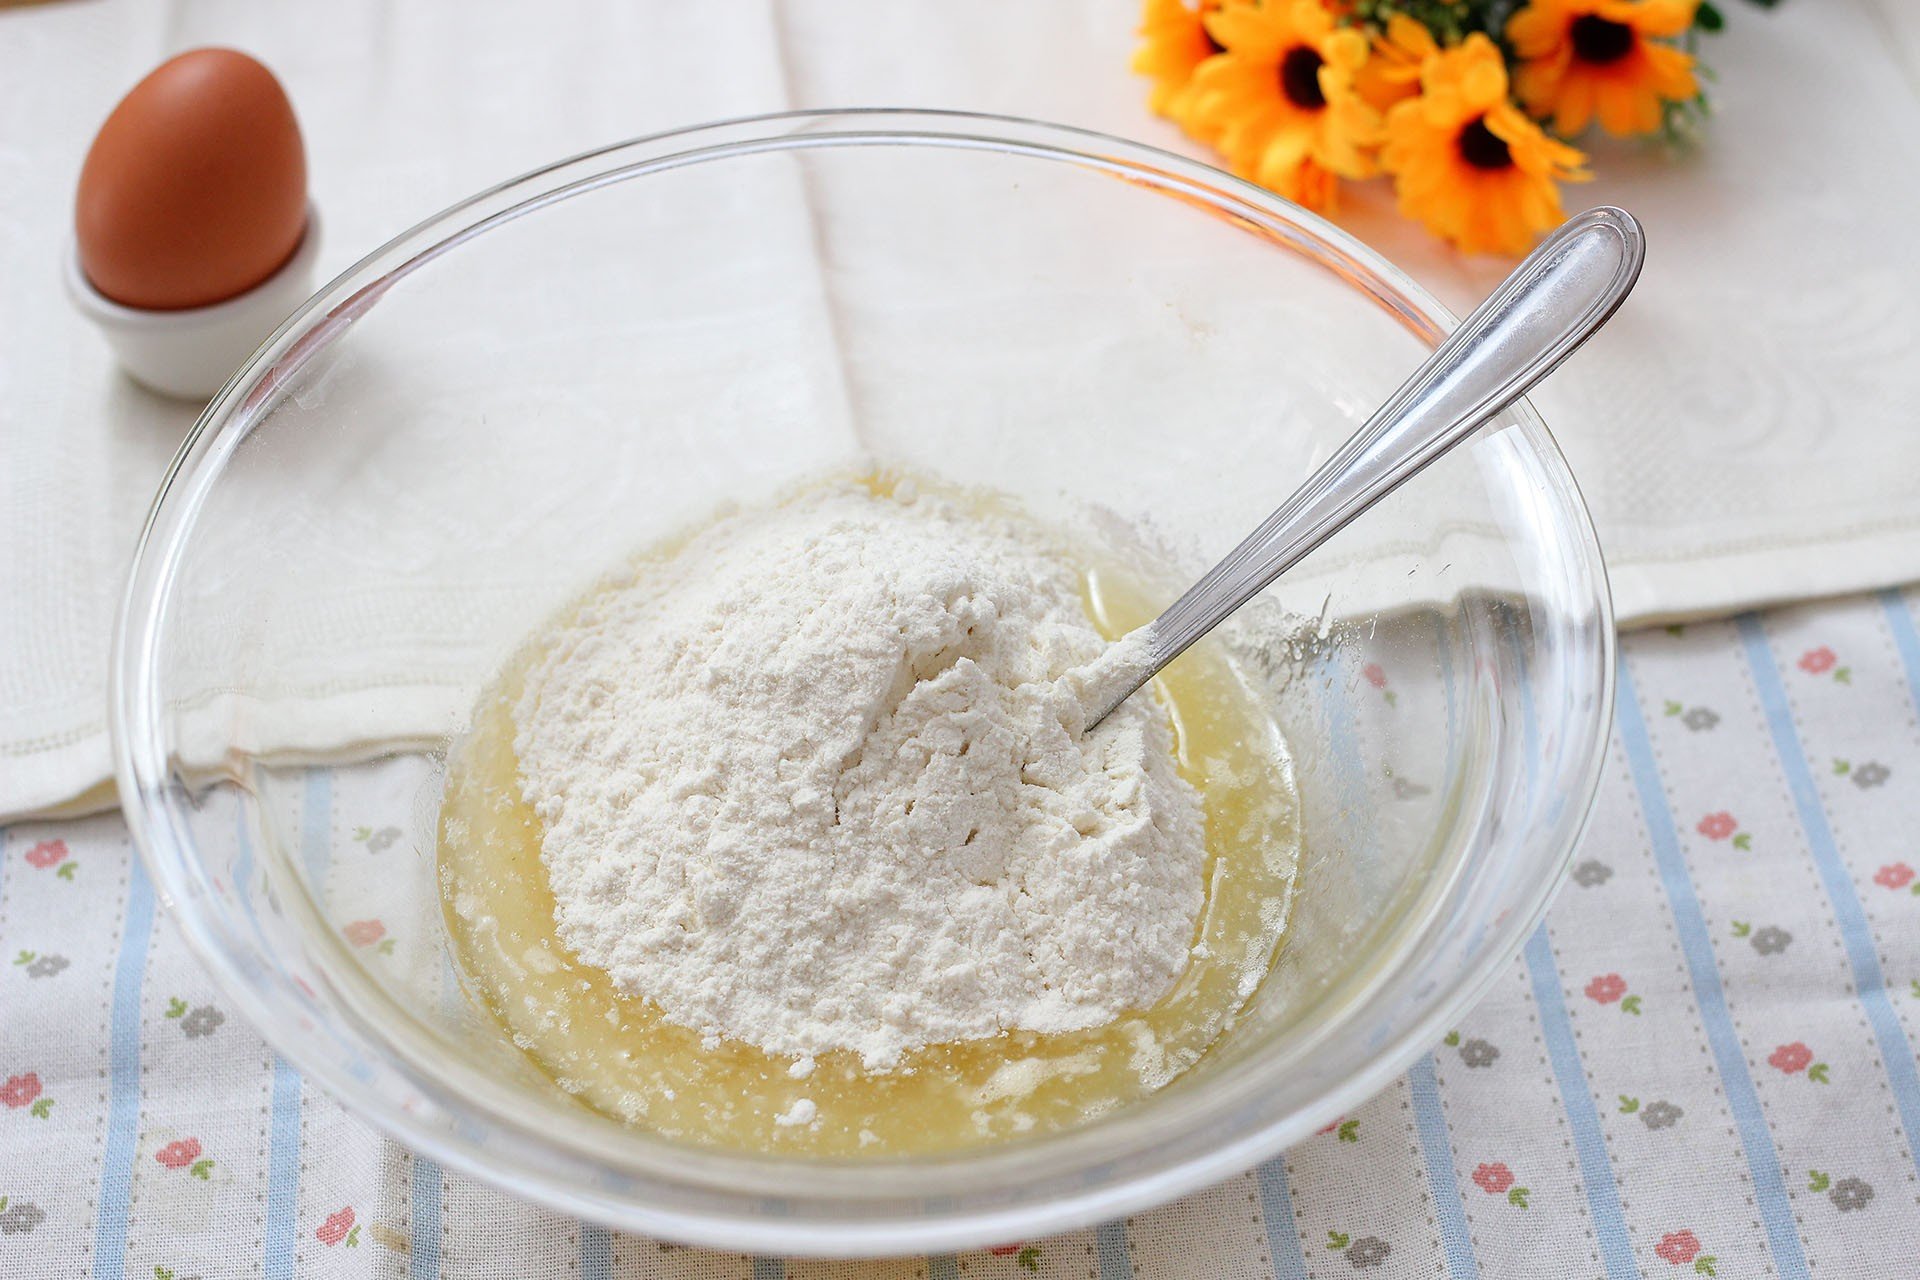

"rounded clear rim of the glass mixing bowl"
[109,107,1615,1257]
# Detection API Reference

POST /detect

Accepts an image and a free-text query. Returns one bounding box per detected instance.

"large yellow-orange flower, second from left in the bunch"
[1190,0,1380,209]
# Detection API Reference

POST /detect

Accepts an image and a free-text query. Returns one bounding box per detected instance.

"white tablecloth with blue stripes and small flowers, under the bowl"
[0,591,1920,1280]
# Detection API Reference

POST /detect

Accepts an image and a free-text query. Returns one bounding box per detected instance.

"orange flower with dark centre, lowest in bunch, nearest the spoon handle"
[1380,33,1590,253]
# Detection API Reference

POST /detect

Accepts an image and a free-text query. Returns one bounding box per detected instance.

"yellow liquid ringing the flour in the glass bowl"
[440,514,1300,1155]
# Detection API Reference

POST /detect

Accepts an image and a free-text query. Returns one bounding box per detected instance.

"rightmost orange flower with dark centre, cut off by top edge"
[1507,0,1699,138]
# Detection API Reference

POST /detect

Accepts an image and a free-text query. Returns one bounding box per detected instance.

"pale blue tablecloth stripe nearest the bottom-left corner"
[94,850,154,1280]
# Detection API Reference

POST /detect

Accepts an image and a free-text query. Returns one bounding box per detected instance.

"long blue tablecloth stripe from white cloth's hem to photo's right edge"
[1740,614,1920,1169]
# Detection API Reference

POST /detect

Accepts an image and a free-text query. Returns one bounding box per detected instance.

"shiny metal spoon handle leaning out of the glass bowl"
[1081,205,1647,729]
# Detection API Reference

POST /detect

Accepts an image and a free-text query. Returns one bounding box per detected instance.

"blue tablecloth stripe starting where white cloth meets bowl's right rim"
[1613,652,1807,1280]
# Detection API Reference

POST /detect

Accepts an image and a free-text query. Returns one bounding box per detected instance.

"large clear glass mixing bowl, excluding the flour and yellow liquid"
[113,111,1613,1255]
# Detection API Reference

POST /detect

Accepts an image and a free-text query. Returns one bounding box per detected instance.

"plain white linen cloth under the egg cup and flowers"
[0,0,1920,816]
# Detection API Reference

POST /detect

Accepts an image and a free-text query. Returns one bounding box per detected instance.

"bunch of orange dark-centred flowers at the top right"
[1133,0,1772,253]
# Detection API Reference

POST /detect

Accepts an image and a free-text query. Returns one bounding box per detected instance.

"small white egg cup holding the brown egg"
[65,201,321,399]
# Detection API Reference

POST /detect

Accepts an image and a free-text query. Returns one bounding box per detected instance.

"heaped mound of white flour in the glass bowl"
[515,486,1202,1069]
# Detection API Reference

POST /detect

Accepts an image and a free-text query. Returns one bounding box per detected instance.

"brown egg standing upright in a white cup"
[73,48,307,311]
